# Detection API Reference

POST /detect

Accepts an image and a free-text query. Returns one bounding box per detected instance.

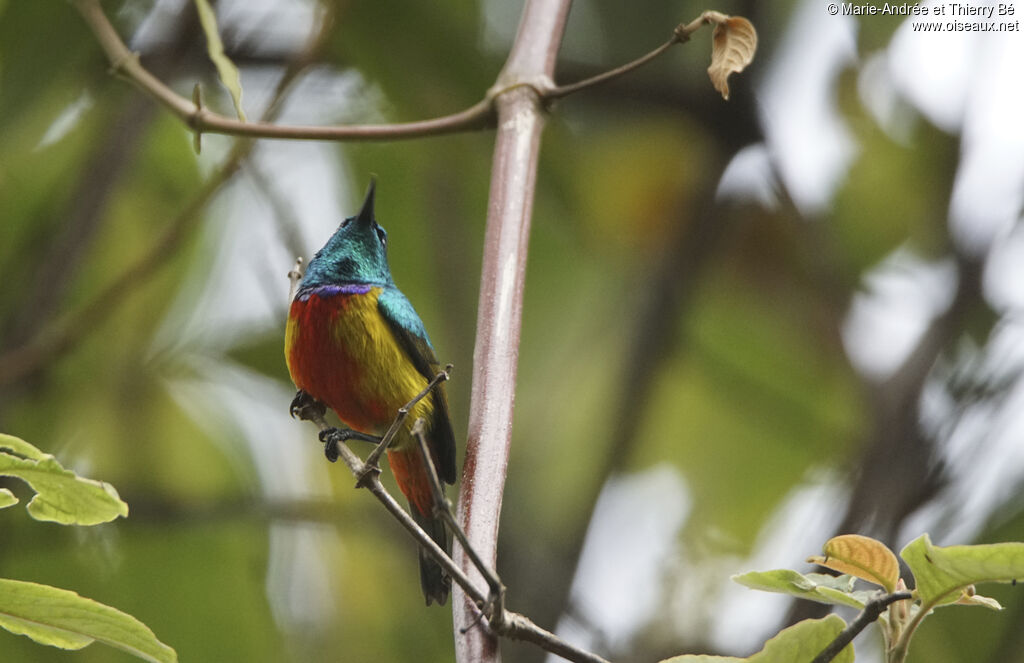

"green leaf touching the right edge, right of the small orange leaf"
[900,534,1024,606]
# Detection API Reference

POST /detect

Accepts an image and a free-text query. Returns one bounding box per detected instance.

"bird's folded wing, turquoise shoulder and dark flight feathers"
[377,288,455,484]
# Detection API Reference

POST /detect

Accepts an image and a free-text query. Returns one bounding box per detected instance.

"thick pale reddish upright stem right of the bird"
[454,0,569,663]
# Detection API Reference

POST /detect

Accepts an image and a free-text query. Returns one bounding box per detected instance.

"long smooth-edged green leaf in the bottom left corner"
[0,578,178,663]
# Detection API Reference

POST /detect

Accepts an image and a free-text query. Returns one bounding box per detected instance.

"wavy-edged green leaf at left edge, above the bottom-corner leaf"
[0,433,128,525]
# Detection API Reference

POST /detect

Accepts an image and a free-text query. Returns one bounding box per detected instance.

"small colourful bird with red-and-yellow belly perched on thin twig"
[285,180,455,606]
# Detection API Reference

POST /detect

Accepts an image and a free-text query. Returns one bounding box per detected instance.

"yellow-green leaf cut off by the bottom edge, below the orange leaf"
[662,615,853,663]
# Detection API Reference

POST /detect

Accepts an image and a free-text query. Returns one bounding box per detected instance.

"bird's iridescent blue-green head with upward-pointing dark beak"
[300,179,394,290]
